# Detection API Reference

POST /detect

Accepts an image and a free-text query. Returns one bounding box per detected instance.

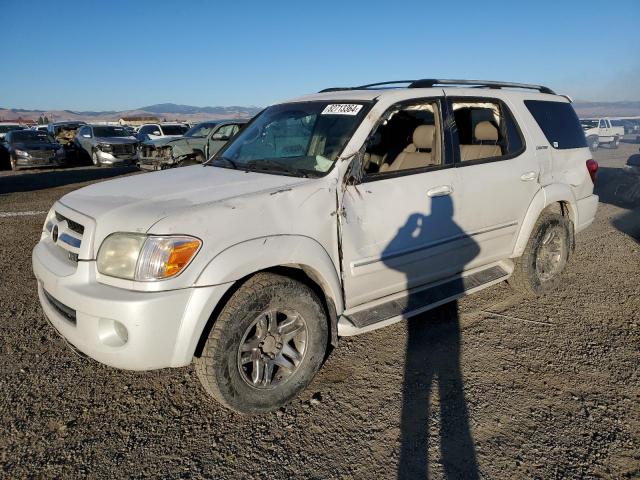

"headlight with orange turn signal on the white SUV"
[97,233,201,281]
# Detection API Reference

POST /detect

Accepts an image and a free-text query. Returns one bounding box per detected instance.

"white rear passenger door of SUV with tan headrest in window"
[448,97,541,269]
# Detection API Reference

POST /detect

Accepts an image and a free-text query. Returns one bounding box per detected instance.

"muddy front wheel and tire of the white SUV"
[196,273,328,413]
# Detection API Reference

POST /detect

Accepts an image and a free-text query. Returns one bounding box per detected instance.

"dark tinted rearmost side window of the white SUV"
[524,100,587,150]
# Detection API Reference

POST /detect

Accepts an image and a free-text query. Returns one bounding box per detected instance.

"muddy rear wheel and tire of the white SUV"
[508,212,573,295]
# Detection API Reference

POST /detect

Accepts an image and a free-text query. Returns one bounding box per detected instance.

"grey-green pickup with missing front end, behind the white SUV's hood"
[138,119,247,170]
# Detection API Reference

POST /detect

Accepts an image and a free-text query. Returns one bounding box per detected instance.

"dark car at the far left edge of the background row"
[3,130,65,170]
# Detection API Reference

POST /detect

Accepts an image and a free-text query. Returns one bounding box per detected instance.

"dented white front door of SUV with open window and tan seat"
[340,98,477,308]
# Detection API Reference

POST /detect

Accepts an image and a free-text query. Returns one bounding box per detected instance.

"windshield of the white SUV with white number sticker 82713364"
[214,102,366,176]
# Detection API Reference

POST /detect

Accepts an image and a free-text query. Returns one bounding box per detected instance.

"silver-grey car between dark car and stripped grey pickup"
[75,125,138,166]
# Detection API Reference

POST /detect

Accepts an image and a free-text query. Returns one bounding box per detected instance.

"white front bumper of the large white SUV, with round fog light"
[32,240,229,370]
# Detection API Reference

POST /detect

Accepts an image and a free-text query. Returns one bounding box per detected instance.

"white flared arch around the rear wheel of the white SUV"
[512,183,578,257]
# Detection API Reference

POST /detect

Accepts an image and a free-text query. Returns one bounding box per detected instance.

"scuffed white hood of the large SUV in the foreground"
[60,165,313,240]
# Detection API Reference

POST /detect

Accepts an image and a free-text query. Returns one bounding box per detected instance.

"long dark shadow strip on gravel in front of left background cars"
[0,166,136,194]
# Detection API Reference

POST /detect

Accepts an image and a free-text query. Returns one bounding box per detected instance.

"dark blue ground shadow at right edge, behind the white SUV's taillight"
[594,167,640,243]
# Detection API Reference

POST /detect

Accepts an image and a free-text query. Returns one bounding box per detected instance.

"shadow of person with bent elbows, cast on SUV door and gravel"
[383,196,480,479]
